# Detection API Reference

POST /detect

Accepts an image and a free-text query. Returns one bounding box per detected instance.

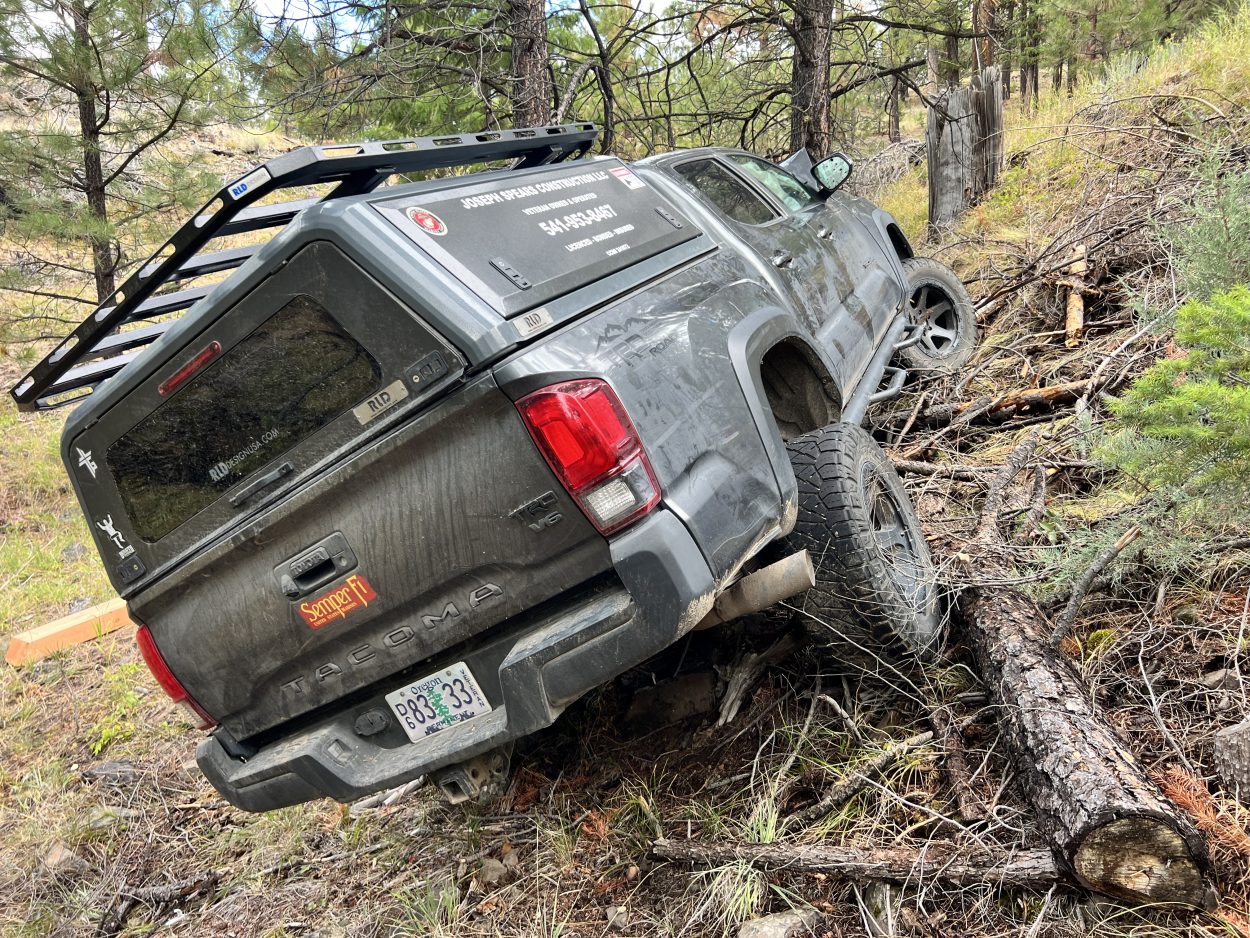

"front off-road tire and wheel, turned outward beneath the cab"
[899,258,976,374]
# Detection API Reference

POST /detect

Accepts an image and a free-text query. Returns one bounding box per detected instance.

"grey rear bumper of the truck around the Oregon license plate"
[196,508,716,810]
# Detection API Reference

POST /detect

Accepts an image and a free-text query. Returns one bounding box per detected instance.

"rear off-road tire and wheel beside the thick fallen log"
[785,424,941,670]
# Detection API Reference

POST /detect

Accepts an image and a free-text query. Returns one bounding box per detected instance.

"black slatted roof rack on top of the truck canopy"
[10,124,599,410]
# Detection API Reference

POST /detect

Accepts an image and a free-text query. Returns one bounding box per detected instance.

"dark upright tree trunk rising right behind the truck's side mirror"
[790,0,834,163]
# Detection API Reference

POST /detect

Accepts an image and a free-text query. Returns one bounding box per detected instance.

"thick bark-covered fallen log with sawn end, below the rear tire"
[961,587,1215,908]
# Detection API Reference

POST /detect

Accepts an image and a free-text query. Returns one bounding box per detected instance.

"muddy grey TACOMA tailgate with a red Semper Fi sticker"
[133,375,611,739]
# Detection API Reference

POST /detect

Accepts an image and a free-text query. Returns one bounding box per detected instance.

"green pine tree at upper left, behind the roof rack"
[0,0,239,322]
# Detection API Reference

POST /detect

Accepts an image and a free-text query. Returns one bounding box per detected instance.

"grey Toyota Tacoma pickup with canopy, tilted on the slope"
[13,124,975,810]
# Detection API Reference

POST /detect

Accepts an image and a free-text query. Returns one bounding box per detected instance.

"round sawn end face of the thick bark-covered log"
[1073,818,1216,910]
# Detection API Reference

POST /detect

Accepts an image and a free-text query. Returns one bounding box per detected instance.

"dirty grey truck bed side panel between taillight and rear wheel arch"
[496,251,798,578]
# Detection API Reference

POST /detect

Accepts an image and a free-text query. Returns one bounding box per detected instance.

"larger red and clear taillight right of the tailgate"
[516,378,660,534]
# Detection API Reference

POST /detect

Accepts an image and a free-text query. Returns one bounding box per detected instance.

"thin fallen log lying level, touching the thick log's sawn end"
[651,839,1060,890]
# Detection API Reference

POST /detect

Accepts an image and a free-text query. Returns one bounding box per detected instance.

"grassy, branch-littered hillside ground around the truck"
[0,8,1250,938]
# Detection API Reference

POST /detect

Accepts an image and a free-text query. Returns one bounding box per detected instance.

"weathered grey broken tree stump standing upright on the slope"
[926,66,1003,231]
